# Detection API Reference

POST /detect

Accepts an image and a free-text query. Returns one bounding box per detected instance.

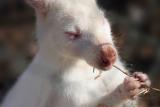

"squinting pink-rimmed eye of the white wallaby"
[65,27,82,40]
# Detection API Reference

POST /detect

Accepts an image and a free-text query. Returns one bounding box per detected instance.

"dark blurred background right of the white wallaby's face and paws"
[99,0,160,107]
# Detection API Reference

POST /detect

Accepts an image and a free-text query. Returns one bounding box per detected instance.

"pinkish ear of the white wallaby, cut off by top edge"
[26,0,47,15]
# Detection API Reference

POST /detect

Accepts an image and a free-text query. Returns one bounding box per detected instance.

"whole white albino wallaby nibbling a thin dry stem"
[1,0,150,107]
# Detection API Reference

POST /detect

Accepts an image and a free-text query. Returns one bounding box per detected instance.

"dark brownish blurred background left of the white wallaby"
[0,0,37,100]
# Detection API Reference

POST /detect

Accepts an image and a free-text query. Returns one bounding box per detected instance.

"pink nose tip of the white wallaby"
[100,45,117,68]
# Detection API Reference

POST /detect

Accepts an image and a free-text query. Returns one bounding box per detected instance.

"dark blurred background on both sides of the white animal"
[0,0,160,107]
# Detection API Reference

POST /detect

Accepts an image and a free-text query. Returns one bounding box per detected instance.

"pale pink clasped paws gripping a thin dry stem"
[123,72,151,99]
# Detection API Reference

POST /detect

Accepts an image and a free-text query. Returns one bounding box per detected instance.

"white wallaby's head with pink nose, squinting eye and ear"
[27,0,117,70]
